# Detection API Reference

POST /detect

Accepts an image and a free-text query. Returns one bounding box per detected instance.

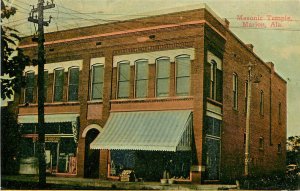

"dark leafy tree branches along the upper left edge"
[1,0,30,100]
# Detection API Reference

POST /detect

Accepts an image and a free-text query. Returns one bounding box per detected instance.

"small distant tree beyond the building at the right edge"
[286,136,300,164]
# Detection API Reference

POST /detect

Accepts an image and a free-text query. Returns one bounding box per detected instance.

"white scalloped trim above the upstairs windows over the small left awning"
[23,60,83,74]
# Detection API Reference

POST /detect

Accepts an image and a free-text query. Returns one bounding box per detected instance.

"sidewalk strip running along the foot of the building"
[1,175,237,190]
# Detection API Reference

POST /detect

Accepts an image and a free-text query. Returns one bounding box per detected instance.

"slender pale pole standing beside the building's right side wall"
[244,63,261,177]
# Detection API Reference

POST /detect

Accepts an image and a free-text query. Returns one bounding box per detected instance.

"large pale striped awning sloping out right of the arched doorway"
[90,110,192,152]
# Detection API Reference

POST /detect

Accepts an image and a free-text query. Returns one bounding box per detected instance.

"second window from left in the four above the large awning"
[135,60,148,98]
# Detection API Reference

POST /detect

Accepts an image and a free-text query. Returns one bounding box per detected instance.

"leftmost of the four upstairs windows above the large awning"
[118,62,130,98]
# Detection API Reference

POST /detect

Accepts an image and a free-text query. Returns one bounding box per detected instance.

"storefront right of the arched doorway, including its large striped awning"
[90,110,193,181]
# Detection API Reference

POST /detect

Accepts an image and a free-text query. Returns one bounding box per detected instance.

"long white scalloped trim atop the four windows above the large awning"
[113,48,195,67]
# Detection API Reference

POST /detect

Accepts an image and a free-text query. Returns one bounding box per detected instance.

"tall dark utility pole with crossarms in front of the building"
[28,0,55,188]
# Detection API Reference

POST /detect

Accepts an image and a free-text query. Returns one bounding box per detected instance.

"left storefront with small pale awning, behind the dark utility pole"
[18,114,79,175]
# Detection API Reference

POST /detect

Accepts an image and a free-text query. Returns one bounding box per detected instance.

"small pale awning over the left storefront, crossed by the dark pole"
[18,113,79,123]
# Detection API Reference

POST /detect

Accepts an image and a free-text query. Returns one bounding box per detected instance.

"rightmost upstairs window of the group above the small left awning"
[68,67,79,101]
